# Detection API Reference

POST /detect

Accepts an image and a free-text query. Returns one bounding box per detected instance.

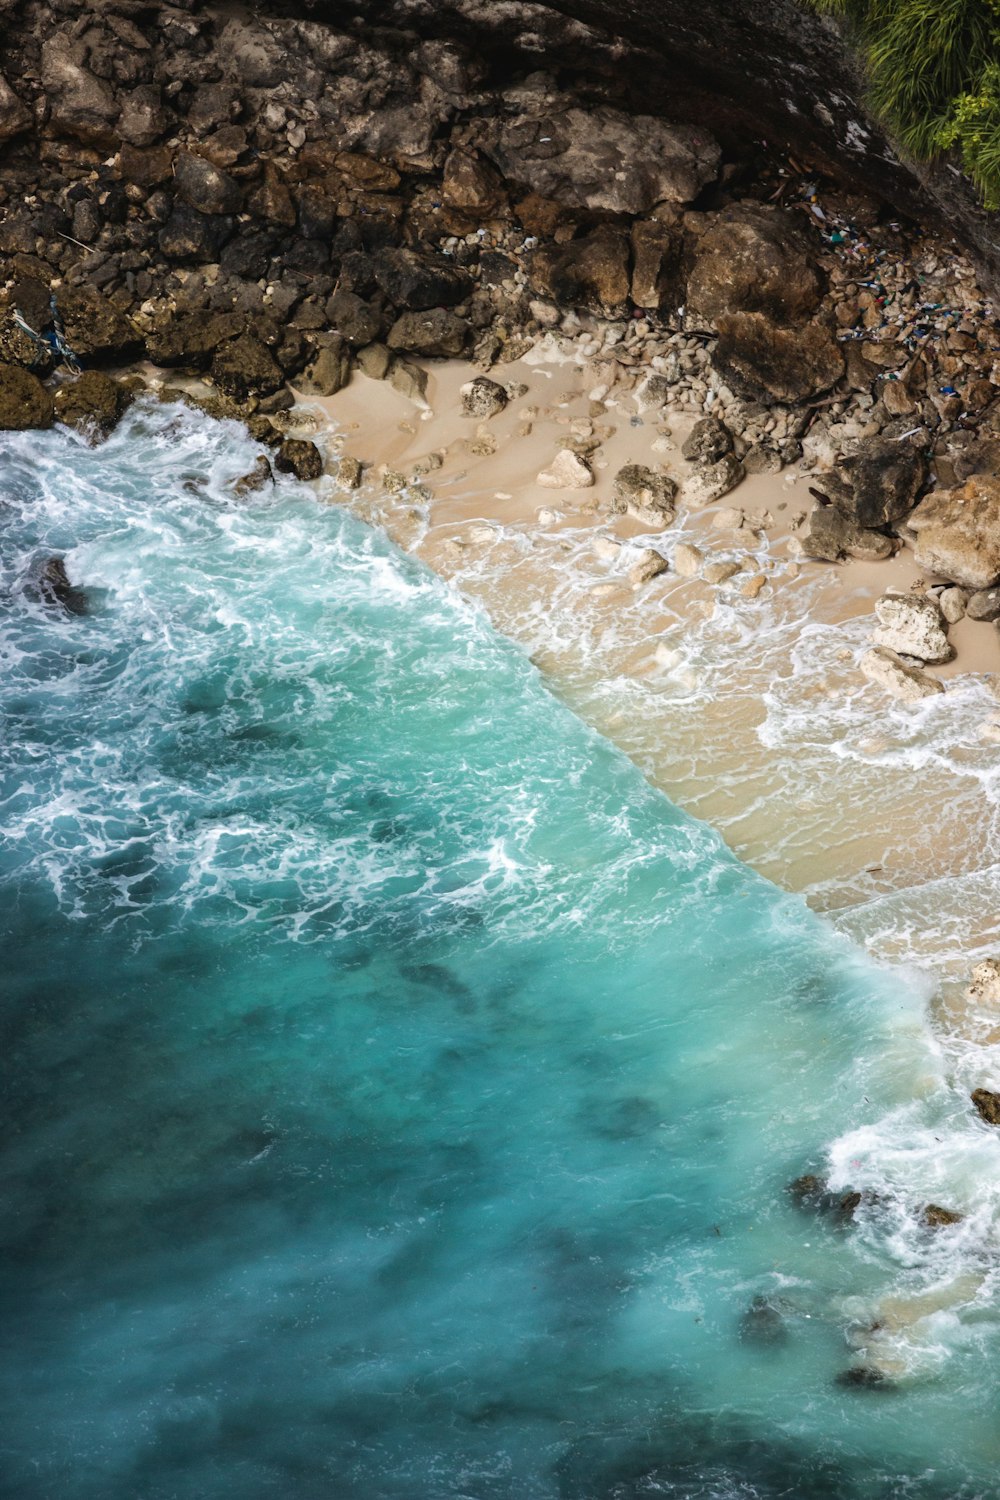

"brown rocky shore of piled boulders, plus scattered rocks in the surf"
[0,0,1000,1383]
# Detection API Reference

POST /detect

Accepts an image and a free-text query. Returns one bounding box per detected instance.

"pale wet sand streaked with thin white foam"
[287,357,1000,1025]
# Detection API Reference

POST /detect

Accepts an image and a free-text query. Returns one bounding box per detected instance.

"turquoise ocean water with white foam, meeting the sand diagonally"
[0,408,1000,1500]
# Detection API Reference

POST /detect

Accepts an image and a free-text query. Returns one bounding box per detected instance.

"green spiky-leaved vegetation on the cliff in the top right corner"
[807,0,1000,210]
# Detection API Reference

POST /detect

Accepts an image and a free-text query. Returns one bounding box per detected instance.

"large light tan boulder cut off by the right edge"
[909,474,1000,590]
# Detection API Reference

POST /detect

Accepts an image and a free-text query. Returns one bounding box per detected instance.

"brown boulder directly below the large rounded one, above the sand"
[712,312,844,405]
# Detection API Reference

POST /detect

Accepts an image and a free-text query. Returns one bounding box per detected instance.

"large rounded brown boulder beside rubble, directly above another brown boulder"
[685,204,823,329]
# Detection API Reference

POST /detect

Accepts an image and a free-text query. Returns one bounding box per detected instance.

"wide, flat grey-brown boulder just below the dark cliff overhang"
[480,107,720,215]
